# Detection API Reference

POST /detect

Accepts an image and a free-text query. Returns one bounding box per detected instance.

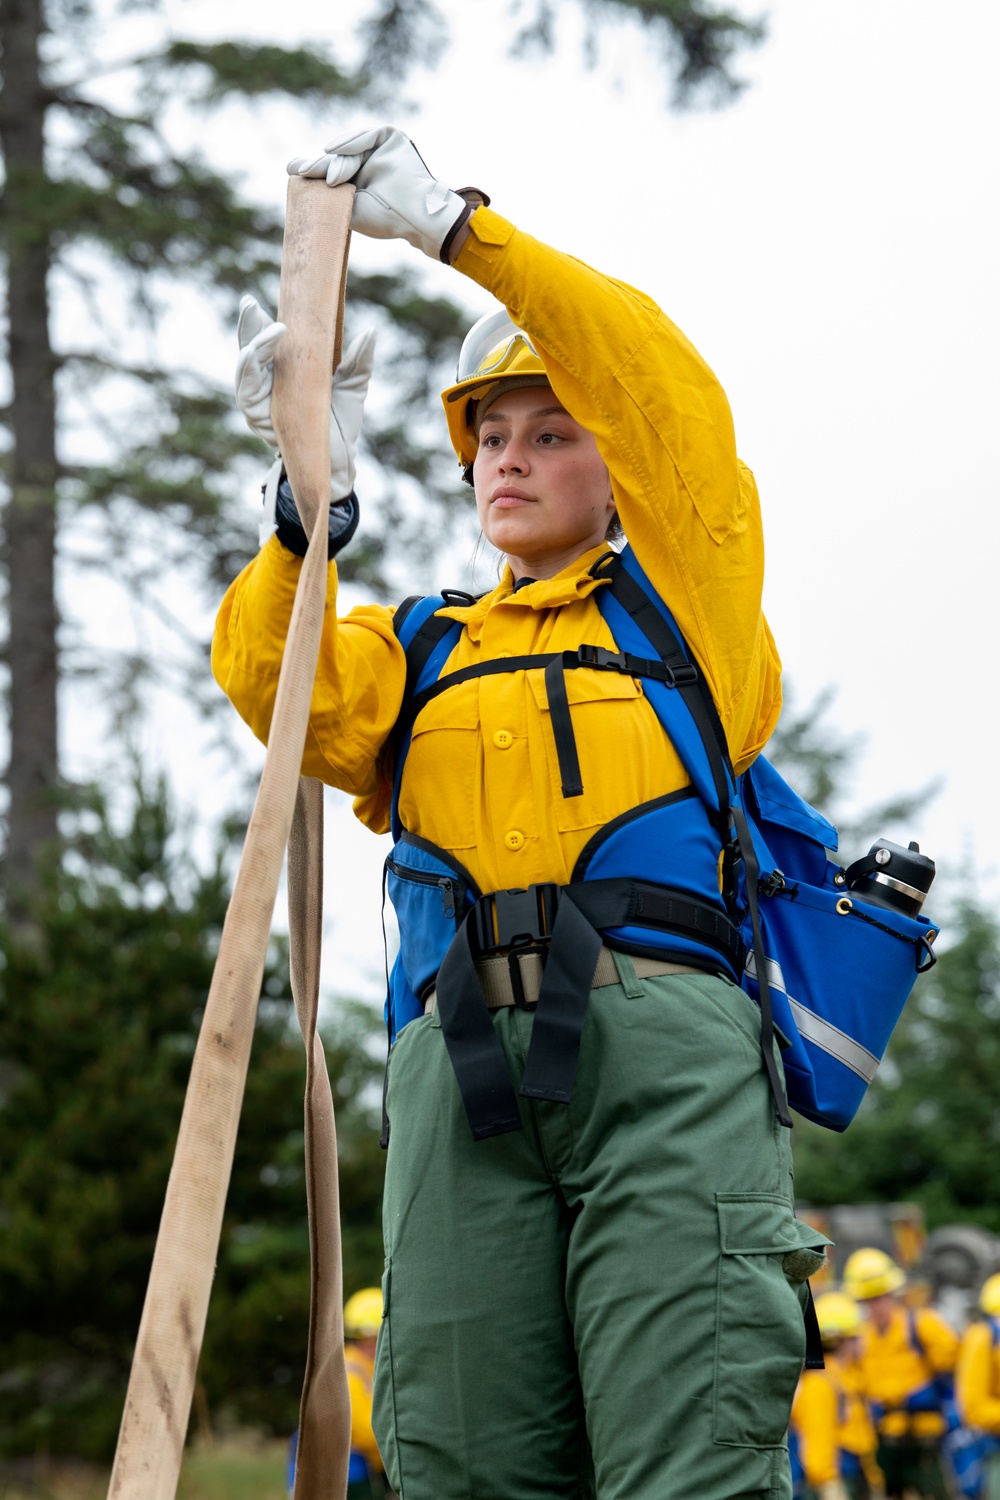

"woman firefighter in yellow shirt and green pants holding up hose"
[213,128,822,1500]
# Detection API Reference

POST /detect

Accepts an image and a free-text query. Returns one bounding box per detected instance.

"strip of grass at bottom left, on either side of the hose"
[0,1436,286,1500]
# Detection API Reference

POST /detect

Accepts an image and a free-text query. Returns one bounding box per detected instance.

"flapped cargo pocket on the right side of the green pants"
[714,1193,829,1448]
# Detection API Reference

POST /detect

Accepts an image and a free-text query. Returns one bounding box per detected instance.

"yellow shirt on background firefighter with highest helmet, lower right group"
[858,1307,958,1437]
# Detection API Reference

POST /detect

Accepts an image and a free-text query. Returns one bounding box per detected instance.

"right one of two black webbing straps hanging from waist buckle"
[520,891,601,1104]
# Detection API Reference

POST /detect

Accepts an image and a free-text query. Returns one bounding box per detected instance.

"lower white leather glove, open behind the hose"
[235,297,375,500]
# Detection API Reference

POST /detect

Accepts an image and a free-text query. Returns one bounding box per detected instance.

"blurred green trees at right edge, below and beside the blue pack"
[795,899,1000,1233]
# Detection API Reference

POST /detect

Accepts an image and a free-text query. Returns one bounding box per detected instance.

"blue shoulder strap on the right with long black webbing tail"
[595,548,792,1130]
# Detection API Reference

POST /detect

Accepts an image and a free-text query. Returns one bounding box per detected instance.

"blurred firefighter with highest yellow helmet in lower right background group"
[844,1248,958,1500]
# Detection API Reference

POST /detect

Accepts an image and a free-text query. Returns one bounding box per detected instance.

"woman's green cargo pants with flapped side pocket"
[373,954,823,1500]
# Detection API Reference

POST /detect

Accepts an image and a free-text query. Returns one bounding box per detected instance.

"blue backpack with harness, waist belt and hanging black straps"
[385,548,936,1139]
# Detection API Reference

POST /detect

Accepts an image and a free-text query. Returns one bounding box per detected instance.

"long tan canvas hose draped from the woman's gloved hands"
[108,177,354,1500]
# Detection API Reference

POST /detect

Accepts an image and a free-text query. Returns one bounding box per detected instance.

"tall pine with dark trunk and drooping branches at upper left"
[0,0,760,918]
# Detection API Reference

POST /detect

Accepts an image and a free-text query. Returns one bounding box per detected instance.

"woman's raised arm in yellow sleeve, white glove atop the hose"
[289,128,781,767]
